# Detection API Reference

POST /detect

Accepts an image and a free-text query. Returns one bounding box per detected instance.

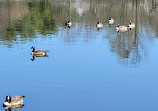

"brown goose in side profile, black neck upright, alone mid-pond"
[31,46,48,57]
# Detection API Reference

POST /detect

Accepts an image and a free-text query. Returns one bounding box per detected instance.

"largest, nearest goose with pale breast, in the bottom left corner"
[3,96,25,107]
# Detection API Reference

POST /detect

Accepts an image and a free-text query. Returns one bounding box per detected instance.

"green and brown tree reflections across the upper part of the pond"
[0,0,158,65]
